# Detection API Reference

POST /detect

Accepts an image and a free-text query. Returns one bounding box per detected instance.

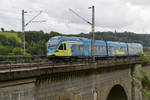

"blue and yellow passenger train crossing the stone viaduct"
[47,36,143,58]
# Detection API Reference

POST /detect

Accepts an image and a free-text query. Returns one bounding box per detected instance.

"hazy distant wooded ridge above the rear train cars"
[76,31,150,47]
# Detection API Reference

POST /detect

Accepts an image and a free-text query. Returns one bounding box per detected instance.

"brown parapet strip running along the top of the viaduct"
[0,57,144,81]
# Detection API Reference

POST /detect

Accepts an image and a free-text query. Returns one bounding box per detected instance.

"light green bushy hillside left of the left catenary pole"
[0,32,22,55]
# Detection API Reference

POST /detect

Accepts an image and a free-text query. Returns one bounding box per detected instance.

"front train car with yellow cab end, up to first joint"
[47,36,107,57]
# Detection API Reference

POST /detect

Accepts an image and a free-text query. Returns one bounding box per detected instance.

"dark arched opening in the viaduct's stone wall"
[106,84,128,100]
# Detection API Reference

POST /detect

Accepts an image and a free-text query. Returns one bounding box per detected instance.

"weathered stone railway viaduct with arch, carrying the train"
[0,57,150,100]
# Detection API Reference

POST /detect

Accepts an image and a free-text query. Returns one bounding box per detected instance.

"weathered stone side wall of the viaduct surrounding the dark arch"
[0,65,139,100]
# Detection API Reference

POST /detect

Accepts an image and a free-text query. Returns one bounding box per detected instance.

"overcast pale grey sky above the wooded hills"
[0,0,150,34]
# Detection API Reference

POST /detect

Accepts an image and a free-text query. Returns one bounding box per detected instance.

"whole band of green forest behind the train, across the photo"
[0,29,150,55]
